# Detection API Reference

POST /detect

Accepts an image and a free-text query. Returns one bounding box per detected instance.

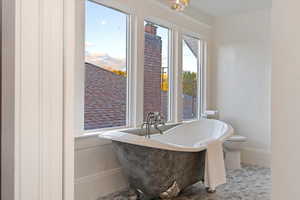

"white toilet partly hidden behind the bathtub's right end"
[224,135,247,169]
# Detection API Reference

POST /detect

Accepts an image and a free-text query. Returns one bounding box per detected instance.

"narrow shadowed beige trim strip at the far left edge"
[1,0,20,200]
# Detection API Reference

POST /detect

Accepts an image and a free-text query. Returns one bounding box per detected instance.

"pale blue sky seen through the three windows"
[85,1,197,72]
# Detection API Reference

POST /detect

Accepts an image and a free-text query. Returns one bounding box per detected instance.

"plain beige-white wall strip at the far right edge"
[272,0,300,200]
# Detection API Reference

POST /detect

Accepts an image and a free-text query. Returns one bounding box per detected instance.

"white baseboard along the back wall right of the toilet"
[241,148,271,167]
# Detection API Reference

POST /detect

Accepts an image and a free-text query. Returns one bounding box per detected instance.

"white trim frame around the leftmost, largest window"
[81,0,136,136]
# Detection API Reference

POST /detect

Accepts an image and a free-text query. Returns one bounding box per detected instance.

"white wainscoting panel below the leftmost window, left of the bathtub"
[75,136,128,200]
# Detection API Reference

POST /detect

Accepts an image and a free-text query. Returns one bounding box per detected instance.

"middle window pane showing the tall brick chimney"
[144,21,170,120]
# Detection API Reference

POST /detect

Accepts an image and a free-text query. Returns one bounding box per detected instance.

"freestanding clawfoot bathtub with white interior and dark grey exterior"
[99,119,233,198]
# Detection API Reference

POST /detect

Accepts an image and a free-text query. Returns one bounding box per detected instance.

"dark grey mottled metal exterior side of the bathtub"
[113,141,205,197]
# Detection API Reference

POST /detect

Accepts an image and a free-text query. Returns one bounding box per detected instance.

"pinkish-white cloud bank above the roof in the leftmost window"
[85,52,126,70]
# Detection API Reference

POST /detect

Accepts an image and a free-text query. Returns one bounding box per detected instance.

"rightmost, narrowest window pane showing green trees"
[182,35,201,120]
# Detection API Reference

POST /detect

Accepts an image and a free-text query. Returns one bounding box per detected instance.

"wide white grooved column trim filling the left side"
[2,0,63,200]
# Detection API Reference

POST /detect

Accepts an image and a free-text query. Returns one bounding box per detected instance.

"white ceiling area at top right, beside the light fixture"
[190,0,272,16]
